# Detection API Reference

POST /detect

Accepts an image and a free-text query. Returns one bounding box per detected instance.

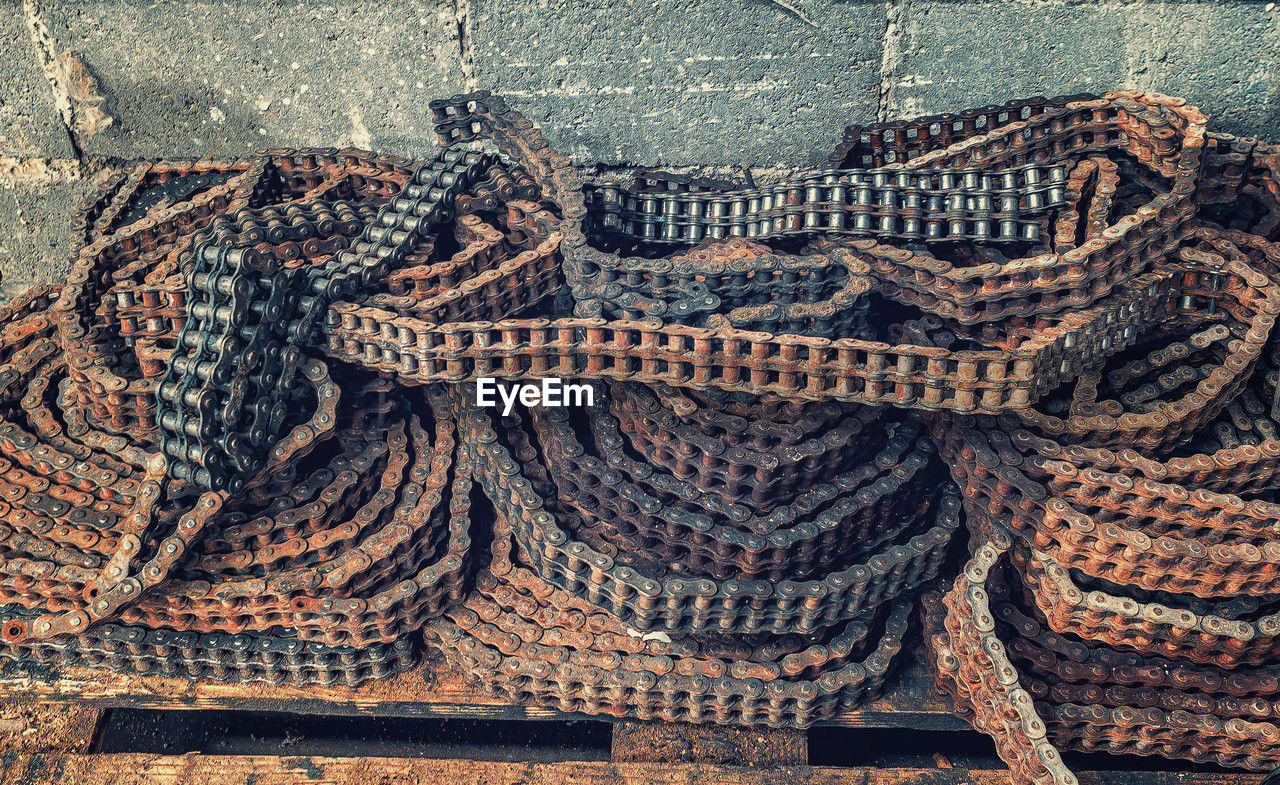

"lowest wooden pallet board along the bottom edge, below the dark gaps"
[0,752,1258,785]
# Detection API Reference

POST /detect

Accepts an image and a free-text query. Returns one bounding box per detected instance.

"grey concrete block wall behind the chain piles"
[0,0,1280,289]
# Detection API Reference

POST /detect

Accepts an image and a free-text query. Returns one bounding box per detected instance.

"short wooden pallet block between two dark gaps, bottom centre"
[609,720,809,766]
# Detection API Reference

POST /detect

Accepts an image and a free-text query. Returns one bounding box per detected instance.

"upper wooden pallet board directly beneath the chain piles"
[0,647,969,730]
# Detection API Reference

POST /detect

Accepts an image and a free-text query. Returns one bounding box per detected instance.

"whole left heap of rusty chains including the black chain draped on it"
[0,144,568,684]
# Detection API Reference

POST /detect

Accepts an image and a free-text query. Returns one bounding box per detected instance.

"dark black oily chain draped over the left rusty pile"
[156,149,495,492]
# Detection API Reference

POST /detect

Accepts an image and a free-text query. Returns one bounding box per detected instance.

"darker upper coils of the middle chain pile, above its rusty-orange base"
[462,376,959,622]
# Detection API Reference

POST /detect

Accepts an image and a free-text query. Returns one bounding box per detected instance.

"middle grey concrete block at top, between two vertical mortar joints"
[472,0,887,165]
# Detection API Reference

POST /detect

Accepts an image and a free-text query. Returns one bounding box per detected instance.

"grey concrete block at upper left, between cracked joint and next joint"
[46,0,473,158]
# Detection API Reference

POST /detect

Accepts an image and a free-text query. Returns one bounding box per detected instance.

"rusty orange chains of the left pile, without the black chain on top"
[0,151,492,684]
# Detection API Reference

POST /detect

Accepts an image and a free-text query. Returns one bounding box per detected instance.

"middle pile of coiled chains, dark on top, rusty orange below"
[425,366,960,726]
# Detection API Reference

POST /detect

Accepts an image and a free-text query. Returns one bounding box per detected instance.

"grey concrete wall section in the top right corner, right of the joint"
[884,0,1280,140]
